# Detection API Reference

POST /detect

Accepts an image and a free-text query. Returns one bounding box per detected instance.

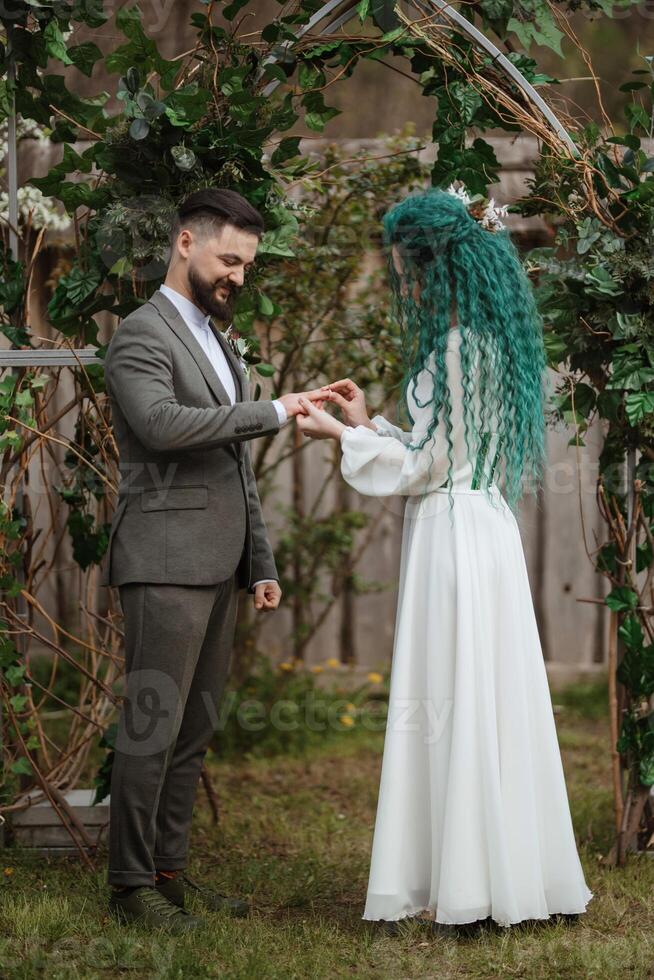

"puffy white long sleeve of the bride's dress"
[341,331,471,497]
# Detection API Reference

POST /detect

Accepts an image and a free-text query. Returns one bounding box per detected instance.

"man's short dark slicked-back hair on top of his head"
[170,187,265,246]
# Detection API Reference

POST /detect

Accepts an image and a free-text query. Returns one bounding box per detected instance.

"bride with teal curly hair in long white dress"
[297,188,592,930]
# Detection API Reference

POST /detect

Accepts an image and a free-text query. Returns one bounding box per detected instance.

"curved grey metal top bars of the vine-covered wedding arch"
[263,0,579,157]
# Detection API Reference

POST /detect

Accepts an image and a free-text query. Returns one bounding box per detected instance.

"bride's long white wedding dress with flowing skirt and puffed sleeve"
[341,327,592,926]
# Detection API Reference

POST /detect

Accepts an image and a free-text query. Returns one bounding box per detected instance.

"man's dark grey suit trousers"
[107,575,238,885]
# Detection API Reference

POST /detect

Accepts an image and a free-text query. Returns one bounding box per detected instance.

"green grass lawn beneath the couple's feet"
[0,685,654,980]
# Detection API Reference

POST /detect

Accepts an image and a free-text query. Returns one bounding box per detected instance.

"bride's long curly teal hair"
[382,188,547,510]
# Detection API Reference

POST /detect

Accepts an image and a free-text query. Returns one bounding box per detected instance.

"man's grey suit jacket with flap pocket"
[101,290,280,592]
